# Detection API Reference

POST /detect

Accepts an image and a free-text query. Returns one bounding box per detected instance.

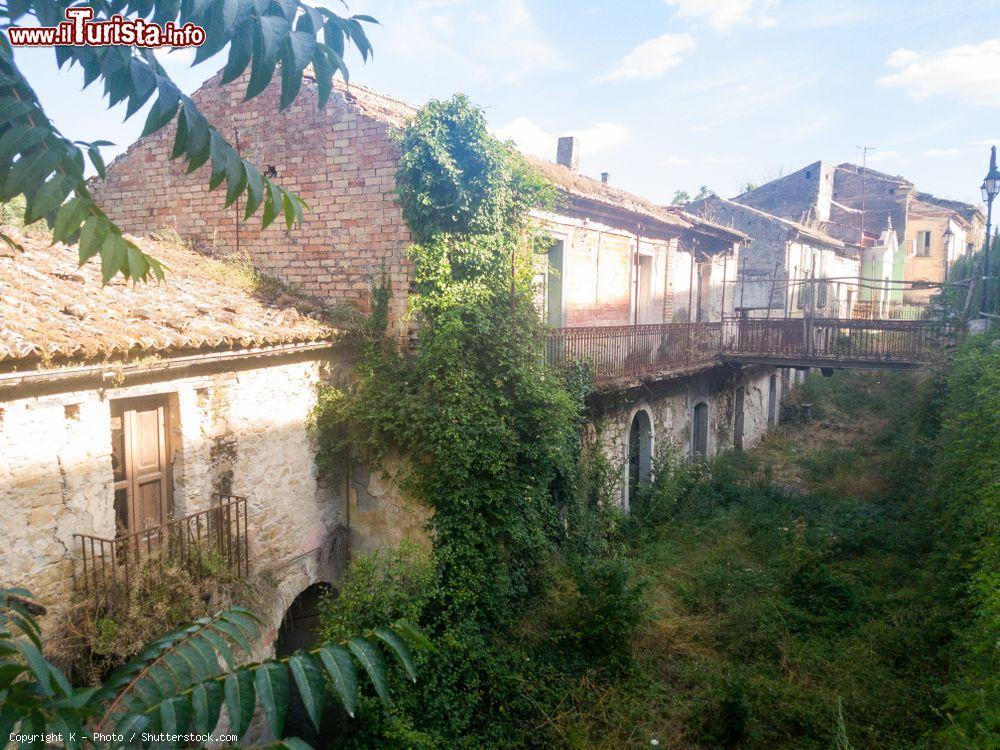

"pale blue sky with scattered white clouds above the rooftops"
[17,0,1000,203]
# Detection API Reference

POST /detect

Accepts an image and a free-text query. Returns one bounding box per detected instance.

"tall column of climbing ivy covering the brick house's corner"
[314,96,583,736]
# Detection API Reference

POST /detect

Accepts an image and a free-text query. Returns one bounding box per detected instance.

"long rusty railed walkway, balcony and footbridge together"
[545,318,961,383]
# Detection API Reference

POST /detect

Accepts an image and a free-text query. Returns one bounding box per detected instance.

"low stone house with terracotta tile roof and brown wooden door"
[0,232,421,645]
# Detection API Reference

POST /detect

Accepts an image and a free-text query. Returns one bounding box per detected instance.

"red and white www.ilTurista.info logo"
[7,6,205,47]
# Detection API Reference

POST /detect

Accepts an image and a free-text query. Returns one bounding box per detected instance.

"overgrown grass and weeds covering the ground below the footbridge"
[541,374,955,750]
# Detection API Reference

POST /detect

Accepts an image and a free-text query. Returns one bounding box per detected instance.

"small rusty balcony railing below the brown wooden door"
[73,494,250,595]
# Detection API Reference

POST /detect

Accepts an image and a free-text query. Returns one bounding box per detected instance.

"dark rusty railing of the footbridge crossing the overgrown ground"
[722,318,961,366]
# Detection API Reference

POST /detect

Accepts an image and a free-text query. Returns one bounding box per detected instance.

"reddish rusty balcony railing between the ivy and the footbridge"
[545,323,722,382]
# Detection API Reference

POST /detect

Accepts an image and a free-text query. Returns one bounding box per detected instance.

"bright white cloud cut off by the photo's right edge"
[876,38,1000,107]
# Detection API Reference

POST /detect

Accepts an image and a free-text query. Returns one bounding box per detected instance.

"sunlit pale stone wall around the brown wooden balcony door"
[0,361,346,627]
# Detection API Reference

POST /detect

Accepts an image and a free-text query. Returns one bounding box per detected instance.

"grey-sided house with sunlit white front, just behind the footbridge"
[687,196,861,318]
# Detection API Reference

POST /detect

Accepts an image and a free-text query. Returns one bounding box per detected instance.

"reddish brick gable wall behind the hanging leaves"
[94,74,410,333]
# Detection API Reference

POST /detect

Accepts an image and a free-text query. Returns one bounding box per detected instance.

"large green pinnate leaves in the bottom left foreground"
[0,590,425,748]
